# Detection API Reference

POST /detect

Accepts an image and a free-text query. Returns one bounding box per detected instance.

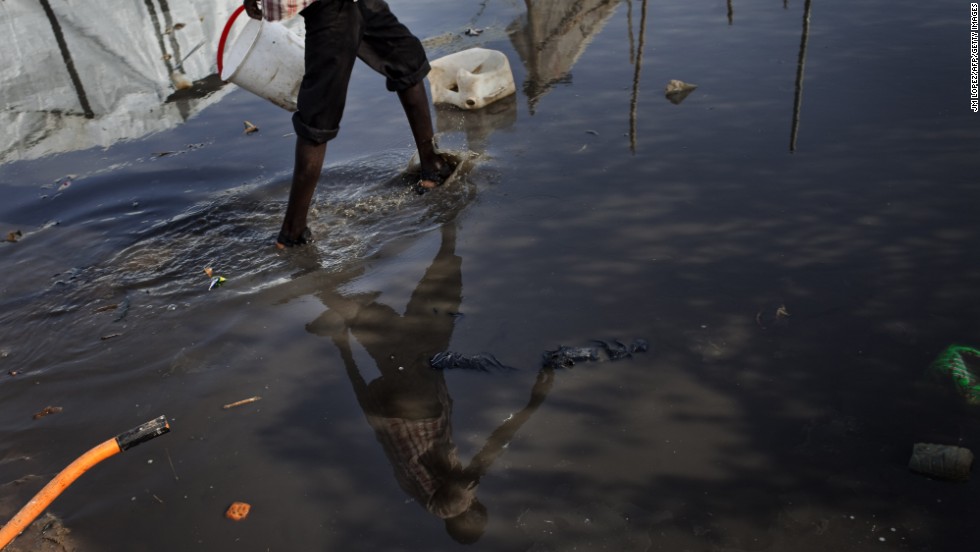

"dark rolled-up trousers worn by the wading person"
[293,0,429,144]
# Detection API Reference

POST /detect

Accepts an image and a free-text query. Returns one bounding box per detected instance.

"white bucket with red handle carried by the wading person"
[218,6,305,111]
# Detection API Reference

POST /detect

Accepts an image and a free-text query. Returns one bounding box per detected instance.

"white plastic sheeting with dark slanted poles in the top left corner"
[0,0,264,163]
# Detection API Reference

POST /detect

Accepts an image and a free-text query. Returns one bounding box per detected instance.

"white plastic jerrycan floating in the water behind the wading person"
[428,48,517,109]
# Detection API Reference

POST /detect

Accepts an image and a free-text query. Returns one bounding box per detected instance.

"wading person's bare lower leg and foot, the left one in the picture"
[276,136,327,249]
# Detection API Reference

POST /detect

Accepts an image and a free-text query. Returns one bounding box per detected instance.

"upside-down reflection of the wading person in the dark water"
[307,222,553,544]
